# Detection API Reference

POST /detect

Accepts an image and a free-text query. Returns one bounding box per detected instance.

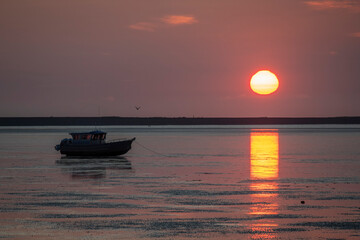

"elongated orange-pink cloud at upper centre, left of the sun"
[129,15,198,32]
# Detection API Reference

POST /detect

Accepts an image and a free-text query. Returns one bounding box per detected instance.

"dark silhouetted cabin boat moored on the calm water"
[55,130,135,156]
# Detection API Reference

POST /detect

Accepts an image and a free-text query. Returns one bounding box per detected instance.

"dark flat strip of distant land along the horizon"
[0,117,360,126]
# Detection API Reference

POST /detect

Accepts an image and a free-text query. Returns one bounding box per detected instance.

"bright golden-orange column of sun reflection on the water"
[249,130,279,239]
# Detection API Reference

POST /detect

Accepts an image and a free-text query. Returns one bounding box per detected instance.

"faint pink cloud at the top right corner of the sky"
[305,0,360,12]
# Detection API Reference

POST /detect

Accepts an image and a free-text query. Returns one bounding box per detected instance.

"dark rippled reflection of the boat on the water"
[56,157,132,179]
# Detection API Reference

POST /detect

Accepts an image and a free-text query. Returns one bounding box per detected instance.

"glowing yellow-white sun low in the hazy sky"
[250,70,279,95]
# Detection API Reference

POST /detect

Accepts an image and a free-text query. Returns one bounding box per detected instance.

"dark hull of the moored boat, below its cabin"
[60,138,135,156]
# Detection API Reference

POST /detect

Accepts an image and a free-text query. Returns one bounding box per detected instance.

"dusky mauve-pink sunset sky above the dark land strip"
[0,0,360,117]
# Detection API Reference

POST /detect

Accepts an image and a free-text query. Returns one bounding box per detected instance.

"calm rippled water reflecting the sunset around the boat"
[0,125,360,239]
